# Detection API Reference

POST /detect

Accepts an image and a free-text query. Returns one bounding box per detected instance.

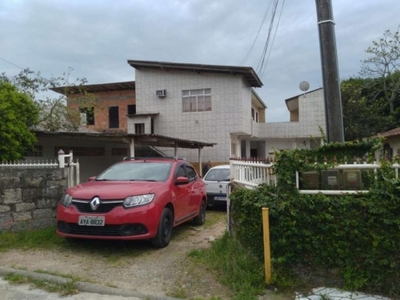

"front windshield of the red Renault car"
[96,162,172,181]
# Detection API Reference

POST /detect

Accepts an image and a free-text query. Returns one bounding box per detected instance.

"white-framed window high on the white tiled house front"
[182,89,211,112]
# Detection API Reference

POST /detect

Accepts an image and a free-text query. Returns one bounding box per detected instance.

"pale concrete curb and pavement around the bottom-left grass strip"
[0,266,177,300]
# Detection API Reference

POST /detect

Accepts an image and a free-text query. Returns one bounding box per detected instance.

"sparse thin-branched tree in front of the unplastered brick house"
[0,69,94,131]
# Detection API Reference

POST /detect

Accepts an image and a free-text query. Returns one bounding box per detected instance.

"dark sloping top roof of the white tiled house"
[128,60,263,87]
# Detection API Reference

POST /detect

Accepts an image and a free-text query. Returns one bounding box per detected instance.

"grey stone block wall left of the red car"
[0,166,67,232]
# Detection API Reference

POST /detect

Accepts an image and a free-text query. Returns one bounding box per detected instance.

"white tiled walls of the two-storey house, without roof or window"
[128,69,325,163]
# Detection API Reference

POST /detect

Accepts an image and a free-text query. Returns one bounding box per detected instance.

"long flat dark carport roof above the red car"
[35,131,216,149]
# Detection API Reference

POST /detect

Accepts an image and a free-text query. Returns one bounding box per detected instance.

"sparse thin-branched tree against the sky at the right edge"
[360,27,400,115]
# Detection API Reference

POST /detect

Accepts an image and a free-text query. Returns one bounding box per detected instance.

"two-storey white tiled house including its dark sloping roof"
[128,60,325,164]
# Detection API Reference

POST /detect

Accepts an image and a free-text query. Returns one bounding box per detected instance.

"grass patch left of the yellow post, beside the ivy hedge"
[189,233,265,300]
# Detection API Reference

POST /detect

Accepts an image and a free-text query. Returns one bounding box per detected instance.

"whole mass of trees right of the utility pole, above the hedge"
[341,25,400,141]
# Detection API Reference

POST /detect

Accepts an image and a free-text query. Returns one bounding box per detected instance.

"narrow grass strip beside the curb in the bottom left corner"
[4,273,79,296]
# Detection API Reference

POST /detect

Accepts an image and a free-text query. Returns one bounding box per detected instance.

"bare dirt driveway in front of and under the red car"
[0,211,236,299]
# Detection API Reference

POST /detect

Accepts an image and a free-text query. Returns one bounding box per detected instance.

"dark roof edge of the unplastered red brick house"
[50,81,135,95]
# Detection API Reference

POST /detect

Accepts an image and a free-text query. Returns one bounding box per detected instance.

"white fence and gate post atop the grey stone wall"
[0,150,80,187]
